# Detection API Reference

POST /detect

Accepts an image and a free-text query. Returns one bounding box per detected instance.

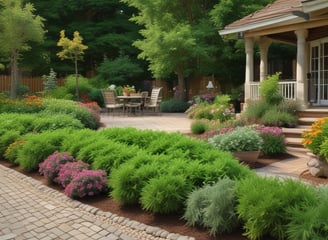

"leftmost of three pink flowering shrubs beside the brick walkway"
[39,151,75,181]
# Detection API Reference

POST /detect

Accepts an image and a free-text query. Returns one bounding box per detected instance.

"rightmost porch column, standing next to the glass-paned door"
[295,29,308,109]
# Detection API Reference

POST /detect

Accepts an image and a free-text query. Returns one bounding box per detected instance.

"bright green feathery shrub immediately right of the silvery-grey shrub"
[236,176,315,240]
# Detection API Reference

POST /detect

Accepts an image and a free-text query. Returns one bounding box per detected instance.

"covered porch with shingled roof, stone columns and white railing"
[220,0,328,109]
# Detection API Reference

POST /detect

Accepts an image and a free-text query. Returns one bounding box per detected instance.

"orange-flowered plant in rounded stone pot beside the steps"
[302,117,328,177]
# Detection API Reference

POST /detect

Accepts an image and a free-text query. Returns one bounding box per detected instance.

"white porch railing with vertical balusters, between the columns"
[249,79,296,100]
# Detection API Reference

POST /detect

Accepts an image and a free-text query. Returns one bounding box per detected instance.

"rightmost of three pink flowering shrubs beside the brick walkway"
[65,170,107,198]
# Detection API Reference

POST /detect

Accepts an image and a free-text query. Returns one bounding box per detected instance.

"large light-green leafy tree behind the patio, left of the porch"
[121,0,217,100]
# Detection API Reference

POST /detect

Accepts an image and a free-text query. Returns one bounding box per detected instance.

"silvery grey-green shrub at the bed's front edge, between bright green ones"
[183,178,239,235]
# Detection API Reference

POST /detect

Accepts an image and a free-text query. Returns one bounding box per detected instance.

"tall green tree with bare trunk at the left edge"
[0,0,45,98]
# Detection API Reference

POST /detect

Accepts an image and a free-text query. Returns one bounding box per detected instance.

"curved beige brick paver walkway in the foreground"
[0,165,194,240]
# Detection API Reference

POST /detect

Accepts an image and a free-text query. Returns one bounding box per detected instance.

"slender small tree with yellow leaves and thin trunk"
[57,30,88,100]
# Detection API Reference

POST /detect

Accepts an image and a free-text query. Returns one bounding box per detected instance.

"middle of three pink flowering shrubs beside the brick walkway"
[54,160,90,188]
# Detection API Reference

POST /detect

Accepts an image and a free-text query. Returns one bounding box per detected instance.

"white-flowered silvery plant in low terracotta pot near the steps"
[209,126,263,162]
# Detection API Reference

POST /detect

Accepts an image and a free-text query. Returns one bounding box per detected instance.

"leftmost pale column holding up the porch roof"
[245,38,254,102]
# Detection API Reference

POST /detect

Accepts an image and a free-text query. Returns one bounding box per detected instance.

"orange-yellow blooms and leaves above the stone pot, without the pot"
[302,117,328,154]
